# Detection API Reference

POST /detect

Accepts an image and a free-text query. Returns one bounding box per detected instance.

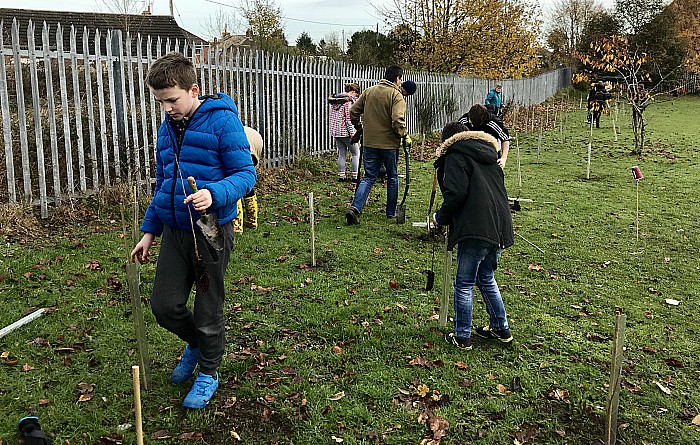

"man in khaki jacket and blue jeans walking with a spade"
[345,65,407,225]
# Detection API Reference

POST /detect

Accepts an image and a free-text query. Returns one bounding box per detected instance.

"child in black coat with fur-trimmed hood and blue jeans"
[432,122,514,349]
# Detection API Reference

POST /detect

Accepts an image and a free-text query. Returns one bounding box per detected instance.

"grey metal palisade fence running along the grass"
[0,21,571,217]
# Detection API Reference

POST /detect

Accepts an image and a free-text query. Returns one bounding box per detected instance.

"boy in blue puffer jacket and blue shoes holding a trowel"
[131,53,257,409]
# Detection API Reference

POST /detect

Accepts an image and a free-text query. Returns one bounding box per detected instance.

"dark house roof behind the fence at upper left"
[0,8,207,54]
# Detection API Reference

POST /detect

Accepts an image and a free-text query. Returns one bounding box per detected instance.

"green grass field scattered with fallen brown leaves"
[0,92,700,445]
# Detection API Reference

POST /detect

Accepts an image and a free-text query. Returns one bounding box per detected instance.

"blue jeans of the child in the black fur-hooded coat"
[454,239,509,338]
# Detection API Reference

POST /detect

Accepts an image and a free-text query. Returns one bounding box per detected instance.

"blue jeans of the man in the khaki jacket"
[352,147,399,216]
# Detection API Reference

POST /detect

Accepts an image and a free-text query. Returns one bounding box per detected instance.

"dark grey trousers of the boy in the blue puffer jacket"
[151,222,233,374]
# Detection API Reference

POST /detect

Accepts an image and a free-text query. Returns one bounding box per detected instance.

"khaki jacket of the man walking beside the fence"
[350,79,407,150]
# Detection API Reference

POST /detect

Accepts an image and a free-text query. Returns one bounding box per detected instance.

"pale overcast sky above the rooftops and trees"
[16,0,614,45]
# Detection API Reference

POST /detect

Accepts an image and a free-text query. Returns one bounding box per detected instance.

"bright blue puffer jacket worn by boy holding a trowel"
[141,93,257,236]
